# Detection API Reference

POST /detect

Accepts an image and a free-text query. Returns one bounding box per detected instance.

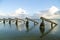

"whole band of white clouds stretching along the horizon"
[0,6,60,19]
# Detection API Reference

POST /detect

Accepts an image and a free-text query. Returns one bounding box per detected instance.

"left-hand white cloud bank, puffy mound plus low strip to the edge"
[0,8,28,18]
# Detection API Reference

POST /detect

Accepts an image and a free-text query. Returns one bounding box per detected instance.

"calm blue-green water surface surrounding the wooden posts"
[0,20,60,40]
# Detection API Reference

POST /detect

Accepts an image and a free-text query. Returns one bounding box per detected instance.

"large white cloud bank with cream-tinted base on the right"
[36,6,60,19]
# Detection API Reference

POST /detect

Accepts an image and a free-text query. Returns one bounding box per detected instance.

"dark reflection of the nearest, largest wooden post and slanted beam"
[40,20,57,40]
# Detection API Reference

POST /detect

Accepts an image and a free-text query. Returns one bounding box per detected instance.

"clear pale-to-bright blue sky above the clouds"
[0,0,60,15]
